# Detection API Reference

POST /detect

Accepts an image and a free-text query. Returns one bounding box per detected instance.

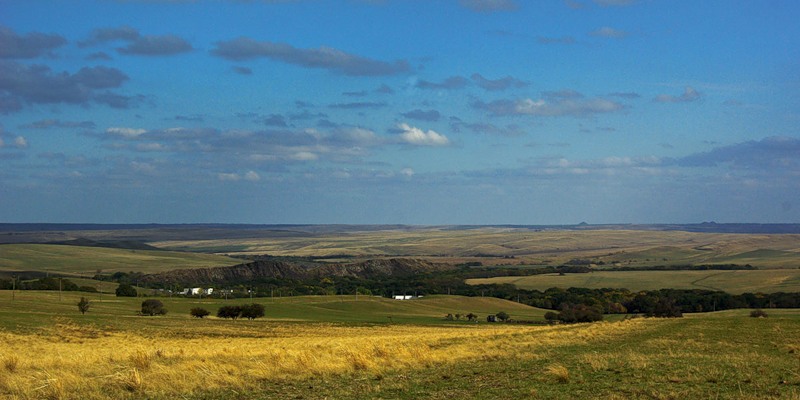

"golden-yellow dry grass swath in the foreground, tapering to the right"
[0,320,646,399]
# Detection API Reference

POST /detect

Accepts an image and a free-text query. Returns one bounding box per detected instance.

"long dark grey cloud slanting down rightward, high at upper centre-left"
[211,37,411,76]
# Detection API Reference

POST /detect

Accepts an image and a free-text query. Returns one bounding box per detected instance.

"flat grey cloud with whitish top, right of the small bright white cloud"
[472,90,625,117]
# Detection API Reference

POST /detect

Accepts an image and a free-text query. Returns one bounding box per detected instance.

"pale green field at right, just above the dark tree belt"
[467,269,800,294]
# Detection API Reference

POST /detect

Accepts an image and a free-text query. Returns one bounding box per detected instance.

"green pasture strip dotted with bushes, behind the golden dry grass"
[0,290,547,330]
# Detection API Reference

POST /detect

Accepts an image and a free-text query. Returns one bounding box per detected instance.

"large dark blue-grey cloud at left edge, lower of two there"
[0,61,134,113]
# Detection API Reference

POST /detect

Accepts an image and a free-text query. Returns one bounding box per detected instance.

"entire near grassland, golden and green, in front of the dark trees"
[0,291,800,399]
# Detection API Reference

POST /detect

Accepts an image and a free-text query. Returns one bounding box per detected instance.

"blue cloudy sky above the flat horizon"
[0,0,800,225]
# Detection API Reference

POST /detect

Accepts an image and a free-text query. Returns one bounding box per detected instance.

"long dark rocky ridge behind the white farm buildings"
[140,258,454,284]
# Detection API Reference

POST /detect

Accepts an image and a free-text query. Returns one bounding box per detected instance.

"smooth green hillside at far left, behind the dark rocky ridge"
[0,244,241,276]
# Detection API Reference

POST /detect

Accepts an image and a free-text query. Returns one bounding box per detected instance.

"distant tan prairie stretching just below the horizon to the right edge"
[150,227,800,268]
